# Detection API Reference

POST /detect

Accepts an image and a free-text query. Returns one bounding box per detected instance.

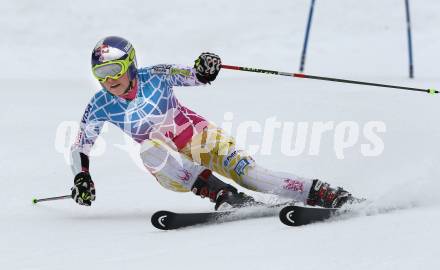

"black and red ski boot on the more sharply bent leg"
[191,169,261,211]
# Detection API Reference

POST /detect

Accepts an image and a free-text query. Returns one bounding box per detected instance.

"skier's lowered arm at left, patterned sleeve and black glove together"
[71,99,104,206]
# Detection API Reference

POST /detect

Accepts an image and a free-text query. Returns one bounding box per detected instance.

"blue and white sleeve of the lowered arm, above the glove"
[71,96,105,175]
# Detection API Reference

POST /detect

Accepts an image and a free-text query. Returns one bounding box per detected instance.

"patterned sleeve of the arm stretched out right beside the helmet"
[150,65,203,86]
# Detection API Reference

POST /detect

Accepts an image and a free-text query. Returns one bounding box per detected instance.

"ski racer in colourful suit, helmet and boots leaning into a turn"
[71,36,354,210]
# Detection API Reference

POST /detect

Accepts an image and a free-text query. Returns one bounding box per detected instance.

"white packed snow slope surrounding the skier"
[0,0,440,270]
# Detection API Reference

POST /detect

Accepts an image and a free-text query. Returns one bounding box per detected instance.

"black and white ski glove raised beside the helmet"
[194,52,222,83]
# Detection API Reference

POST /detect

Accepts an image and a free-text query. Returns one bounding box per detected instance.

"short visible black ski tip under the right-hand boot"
[280,205,340,226]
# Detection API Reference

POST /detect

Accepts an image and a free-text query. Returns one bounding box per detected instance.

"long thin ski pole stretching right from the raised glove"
[221,65,440,95]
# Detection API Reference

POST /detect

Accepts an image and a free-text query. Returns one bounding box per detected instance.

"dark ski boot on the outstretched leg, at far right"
[307,179,360,208]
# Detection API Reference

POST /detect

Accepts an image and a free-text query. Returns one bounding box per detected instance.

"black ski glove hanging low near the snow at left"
[71,172,96,206]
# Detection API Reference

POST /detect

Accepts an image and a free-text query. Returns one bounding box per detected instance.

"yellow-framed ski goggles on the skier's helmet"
[92,50,135,82]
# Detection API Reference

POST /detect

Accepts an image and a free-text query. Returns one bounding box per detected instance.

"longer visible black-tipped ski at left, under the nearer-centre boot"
[151,203,290,230]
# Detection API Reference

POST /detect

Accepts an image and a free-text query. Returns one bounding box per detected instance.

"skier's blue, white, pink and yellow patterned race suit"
[71,65,312,202]
